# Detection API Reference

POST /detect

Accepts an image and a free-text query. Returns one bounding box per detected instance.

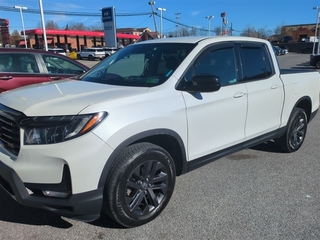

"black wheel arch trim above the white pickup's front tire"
[98,129,187,187]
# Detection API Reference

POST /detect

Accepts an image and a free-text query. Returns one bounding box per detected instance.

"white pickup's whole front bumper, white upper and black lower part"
[0,127,112,221]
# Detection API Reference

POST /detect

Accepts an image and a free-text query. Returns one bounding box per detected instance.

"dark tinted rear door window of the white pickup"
[241,44,274,81]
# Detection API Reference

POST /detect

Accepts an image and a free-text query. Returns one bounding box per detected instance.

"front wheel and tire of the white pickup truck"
[103,143,176,227]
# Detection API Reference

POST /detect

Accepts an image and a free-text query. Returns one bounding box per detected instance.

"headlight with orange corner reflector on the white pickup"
[20,112,107,145]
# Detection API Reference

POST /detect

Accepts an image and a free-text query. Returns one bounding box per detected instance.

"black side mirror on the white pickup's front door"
[177,74,221,92]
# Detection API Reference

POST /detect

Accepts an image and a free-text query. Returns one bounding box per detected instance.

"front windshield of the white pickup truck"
[80,43,195,87]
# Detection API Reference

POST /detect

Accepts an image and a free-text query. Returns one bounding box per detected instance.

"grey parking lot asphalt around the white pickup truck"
[0,53,320,240]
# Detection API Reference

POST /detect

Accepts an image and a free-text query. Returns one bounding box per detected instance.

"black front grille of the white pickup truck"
[0,104,21,155]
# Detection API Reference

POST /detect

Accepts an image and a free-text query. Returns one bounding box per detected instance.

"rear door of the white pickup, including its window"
[239,43,284,140]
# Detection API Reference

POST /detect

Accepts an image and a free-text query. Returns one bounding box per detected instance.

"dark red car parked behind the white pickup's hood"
[0,48,89,92]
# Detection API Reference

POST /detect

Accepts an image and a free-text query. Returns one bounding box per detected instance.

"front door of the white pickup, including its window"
[182,43,247,160]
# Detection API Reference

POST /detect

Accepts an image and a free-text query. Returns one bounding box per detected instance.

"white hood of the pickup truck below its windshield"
[0,80,148,116]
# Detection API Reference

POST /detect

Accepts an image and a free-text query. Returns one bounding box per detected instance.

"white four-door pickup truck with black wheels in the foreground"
[0,37,320,227]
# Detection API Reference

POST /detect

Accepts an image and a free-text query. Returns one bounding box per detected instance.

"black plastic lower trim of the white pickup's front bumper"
[0,158,103,221]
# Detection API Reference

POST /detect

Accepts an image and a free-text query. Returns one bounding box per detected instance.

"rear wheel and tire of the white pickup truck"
[276,108,308,153]
